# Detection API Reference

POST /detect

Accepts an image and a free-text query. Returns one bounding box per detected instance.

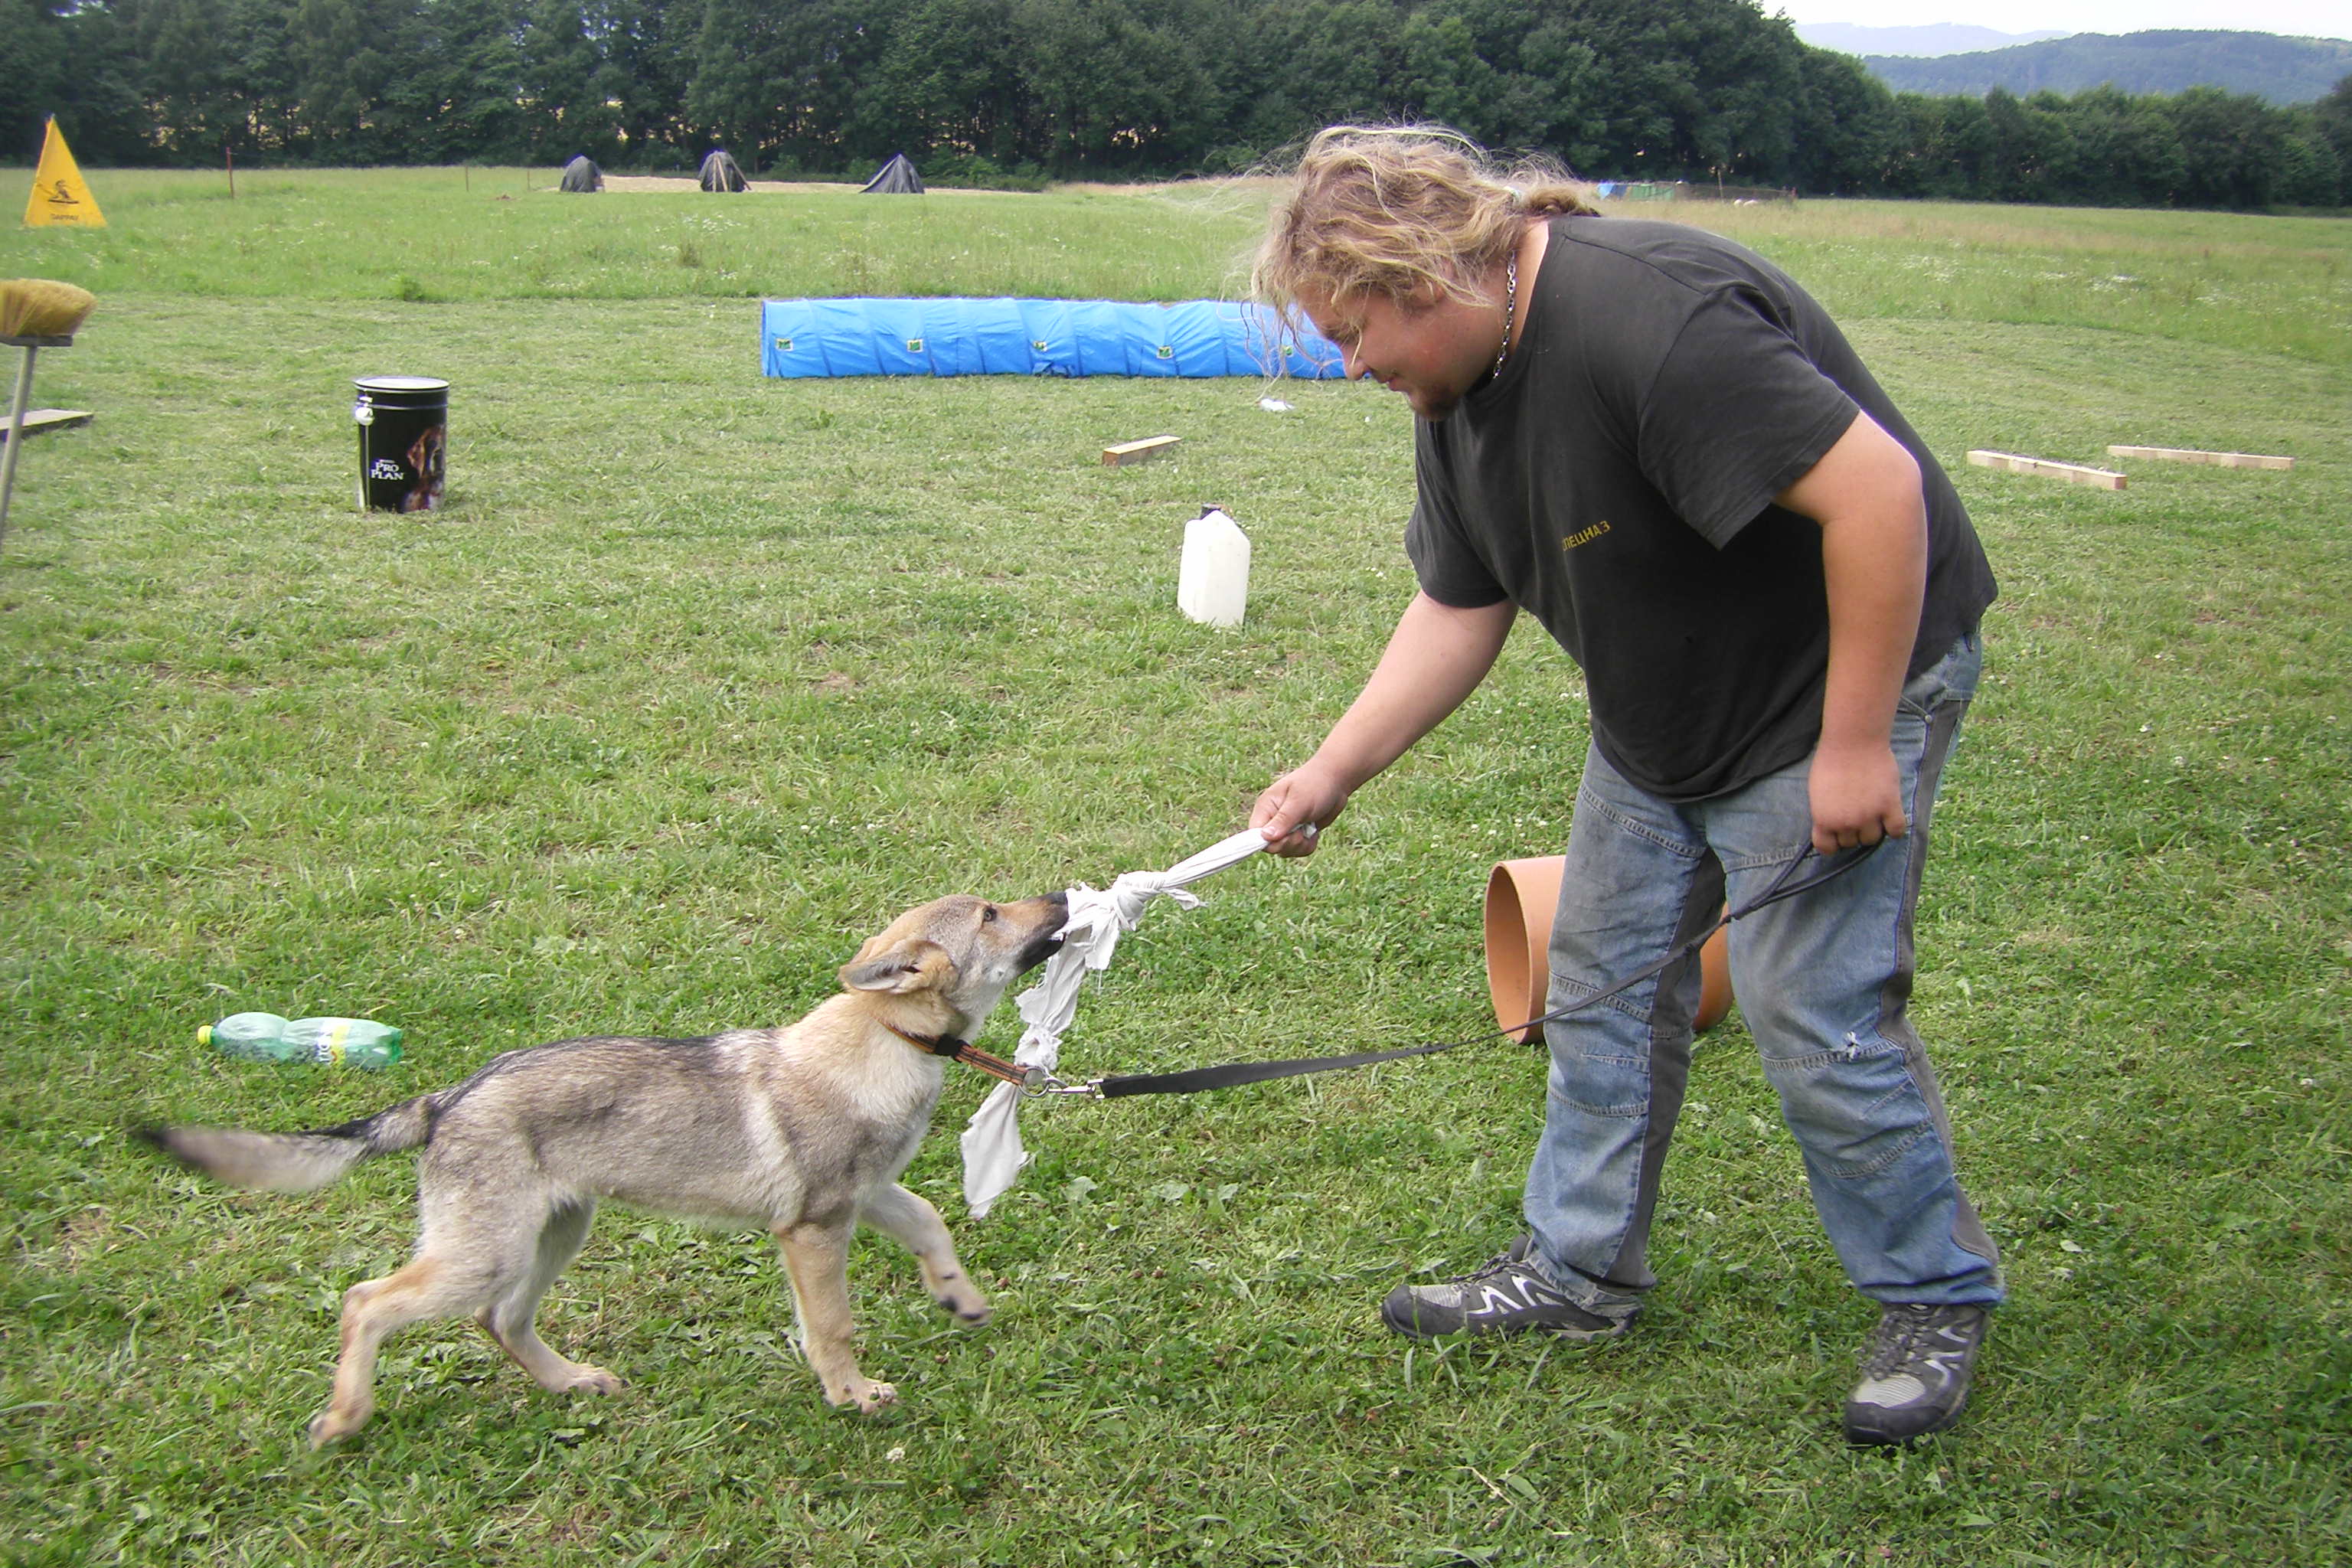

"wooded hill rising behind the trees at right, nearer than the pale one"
[1863,33,2352,103]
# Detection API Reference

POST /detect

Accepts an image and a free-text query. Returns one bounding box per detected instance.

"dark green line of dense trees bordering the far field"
[0,0,2352,207]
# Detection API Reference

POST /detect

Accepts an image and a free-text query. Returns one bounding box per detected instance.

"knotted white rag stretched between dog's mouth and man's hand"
[965,828,1266,1215]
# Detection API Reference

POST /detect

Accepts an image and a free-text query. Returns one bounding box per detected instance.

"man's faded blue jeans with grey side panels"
[1527,632,2001,1319]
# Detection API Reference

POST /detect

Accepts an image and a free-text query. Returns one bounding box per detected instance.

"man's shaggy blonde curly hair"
[1249,125,1597,315]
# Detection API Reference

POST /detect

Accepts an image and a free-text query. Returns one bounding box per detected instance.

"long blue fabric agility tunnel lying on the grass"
[760,299,1343,381]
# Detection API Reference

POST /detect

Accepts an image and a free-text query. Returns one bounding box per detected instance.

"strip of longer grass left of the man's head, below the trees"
[0,169,1269,303]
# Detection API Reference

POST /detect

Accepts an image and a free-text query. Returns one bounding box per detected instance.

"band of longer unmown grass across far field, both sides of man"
[0,169,2352,364]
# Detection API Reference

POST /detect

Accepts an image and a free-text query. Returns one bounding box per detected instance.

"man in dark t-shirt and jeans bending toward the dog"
[1251,127,2001,1443]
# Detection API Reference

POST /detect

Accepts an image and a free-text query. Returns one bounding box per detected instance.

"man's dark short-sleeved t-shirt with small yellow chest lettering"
[1404,216,1994,799]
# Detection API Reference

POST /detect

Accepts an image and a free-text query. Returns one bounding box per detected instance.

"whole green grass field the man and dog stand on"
[0,169,2352,1568]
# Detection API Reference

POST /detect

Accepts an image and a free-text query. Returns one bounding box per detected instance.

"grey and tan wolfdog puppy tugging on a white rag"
[139,893,1068,1446]
